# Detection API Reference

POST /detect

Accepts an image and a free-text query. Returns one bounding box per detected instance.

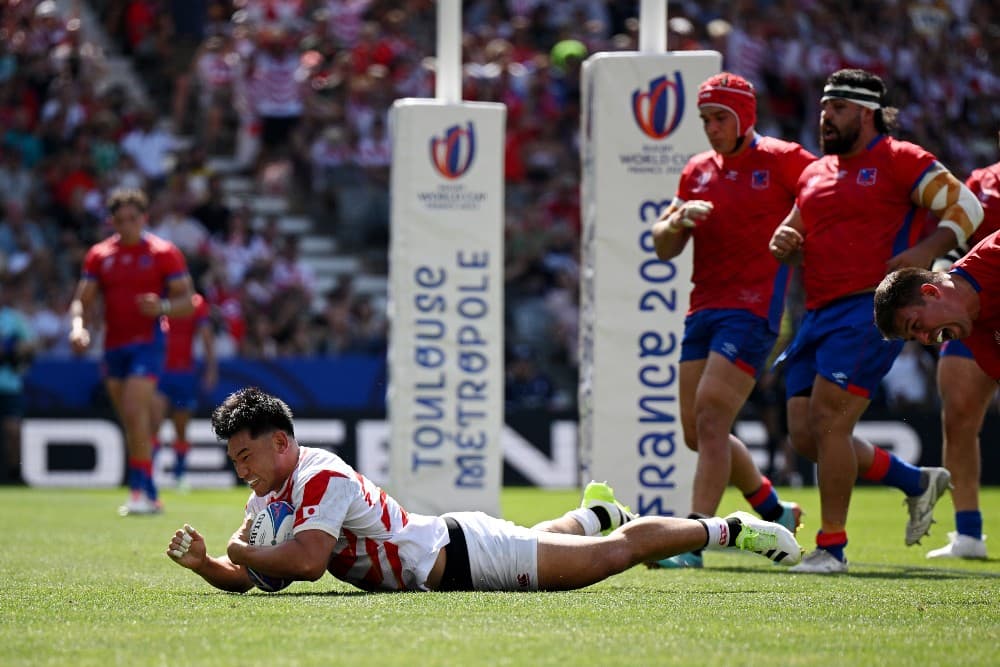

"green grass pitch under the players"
[0,487,1000,667]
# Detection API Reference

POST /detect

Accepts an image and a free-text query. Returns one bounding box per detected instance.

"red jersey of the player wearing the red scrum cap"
[674,135,816,317]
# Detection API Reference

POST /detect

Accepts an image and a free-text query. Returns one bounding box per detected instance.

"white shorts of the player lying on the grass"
[443,512,538,591]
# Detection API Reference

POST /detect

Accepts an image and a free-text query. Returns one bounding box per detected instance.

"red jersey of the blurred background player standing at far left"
[82,232,187,350]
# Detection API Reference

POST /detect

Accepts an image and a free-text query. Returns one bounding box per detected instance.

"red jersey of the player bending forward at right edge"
[951,232,1000,381]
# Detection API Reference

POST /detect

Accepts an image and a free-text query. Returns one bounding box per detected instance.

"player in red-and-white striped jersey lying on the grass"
[167,388,802,592]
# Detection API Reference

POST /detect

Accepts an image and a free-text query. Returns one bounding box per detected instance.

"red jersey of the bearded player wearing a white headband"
[795,135,937,310]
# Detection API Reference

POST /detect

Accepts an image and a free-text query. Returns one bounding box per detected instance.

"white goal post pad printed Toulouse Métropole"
[388,99,506,516]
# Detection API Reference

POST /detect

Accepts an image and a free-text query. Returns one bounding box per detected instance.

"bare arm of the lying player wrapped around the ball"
[226,523,337,581]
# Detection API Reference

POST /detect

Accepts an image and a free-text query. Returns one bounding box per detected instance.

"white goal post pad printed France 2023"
[579,51,722,516]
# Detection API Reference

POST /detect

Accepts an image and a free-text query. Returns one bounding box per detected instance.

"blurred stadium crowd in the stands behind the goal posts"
[0,0,1000,420]
